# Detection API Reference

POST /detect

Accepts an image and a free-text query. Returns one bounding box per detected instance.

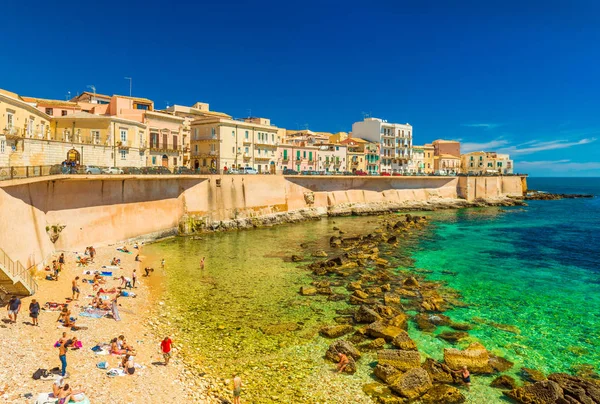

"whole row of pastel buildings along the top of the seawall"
[0,89,513,175]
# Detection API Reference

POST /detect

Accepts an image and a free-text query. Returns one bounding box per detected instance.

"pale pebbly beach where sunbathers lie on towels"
[0,246,209,403]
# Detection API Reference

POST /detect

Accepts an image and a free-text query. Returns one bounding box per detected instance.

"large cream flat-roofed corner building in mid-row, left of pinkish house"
[190,117,281,173]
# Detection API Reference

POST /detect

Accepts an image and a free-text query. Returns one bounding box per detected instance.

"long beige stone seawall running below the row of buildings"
[0,175,525,266]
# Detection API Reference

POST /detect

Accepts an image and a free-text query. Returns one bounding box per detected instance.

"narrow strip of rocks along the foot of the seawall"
[178,197,526,235]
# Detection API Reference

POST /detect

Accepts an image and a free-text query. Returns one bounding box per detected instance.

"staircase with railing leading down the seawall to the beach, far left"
[0,248,38,301]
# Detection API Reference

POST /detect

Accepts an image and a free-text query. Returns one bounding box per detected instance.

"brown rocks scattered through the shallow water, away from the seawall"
[291,214,600,404]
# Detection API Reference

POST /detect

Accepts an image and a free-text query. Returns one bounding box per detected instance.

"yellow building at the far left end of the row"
[0,89,50,166]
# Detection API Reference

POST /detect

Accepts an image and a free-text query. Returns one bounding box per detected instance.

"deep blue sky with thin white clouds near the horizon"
[0,0,600,176]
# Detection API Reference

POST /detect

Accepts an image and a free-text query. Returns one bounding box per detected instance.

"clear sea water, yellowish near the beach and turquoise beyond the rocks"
[144,179,600,403]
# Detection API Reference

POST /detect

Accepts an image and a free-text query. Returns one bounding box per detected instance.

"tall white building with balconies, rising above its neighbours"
[352,118,412,173]
